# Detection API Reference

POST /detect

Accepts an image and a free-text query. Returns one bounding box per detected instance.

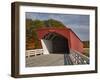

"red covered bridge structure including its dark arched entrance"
[37,28,83,54]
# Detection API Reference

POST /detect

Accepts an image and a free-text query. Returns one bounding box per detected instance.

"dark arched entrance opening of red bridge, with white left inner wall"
[41,33,69,54]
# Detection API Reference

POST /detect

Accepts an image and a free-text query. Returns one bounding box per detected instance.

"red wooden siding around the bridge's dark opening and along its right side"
[37,28,83,53]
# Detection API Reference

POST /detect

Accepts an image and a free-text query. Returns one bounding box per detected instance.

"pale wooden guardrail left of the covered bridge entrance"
[26,49,43,58]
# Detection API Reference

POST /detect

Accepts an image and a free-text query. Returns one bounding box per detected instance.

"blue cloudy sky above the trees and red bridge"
[26,12,90,41]
